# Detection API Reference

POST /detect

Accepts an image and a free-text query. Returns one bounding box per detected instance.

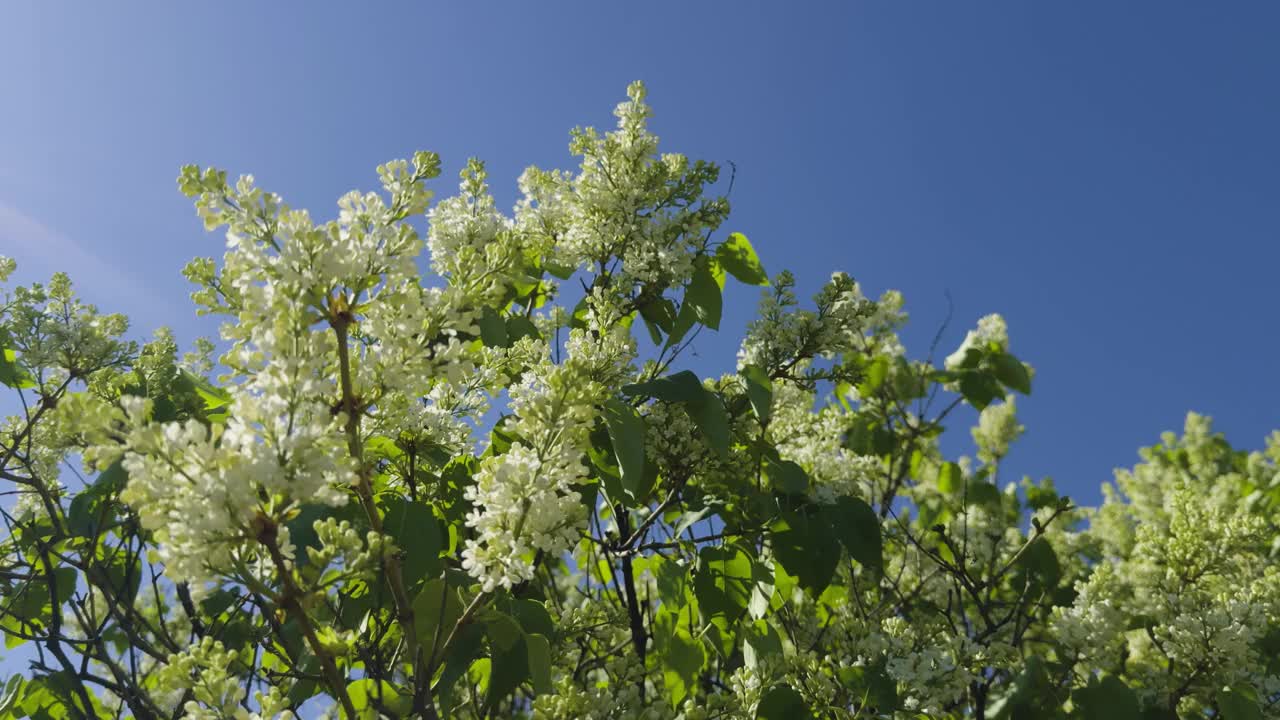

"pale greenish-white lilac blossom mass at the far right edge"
[1055,414,1280,707]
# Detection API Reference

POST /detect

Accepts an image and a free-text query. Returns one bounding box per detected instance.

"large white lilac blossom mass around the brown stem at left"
[101,154,504,592]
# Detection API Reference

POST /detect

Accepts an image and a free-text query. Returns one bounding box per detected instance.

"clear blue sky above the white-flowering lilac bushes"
[0,1,1280,502]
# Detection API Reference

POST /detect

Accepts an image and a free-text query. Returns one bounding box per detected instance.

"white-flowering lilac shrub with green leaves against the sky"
[0,83,1280,720]
